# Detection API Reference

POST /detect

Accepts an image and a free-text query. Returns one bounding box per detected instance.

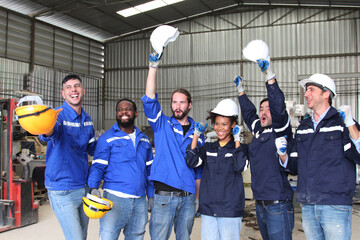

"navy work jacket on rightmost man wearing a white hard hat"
[286,106,360,205]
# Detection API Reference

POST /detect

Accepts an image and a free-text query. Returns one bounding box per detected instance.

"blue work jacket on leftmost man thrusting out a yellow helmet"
[39,102,96,190]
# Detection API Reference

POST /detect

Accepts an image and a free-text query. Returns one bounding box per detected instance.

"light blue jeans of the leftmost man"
[48,188,89,240]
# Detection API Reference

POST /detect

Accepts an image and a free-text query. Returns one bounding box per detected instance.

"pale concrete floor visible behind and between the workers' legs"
[0,201,360,240]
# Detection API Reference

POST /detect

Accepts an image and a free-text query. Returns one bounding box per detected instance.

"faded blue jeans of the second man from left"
[100,191,148,240]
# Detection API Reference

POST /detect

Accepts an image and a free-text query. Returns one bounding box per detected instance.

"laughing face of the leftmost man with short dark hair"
[62,78,85,107]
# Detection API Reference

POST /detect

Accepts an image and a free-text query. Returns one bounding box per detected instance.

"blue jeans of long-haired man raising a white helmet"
[149,194,195,240]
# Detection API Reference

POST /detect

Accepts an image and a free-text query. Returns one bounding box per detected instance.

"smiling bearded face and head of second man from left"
[116,100,138,129]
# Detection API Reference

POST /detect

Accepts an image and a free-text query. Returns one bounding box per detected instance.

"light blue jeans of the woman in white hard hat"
[201,214,242,240]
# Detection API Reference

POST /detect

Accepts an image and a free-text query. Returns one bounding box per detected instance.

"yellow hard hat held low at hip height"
[83,193,113,219]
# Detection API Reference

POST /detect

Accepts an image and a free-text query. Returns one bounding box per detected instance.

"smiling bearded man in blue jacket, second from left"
[88,98,154,240]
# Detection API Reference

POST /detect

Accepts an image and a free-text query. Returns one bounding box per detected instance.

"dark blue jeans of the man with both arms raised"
[256,202,294,240]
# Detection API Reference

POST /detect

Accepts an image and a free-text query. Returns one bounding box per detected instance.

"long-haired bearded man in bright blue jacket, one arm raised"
[142,54,204,240]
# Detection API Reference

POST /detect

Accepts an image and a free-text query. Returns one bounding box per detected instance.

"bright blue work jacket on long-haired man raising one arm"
[141,94,204,194]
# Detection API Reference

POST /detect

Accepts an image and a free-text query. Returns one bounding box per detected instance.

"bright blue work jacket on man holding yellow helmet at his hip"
[88,123,154,198]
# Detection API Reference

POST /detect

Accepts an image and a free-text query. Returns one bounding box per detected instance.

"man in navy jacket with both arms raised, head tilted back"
[234,59,294,240]
